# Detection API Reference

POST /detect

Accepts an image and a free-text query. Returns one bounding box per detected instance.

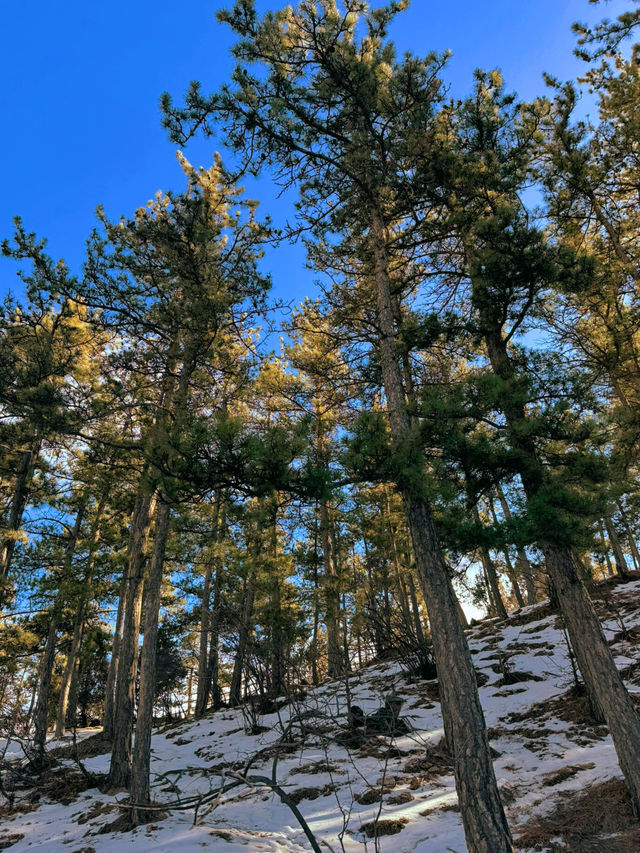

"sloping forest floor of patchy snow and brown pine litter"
[0,576,640,853]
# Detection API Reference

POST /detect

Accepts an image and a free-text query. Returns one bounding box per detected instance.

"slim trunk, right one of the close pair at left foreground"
[129,499,171,826]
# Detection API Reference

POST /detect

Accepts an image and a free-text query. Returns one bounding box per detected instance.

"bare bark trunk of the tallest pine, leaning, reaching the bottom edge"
[370,209,513,853]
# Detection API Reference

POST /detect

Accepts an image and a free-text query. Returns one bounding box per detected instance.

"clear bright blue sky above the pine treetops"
[0,0,628,301]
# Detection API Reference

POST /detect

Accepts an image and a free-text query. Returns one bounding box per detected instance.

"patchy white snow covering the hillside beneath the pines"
[5,581,640,853]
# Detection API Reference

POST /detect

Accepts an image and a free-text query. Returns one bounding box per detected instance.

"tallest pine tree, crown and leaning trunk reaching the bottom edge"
[165,0,512,853]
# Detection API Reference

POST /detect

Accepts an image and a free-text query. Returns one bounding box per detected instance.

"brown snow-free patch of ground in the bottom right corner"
[515,779,640,853]
